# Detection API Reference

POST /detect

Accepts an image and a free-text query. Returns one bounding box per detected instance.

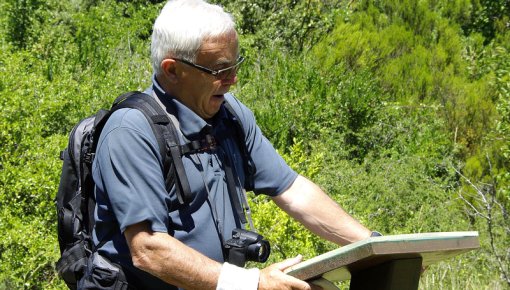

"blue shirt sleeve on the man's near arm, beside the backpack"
[93,109,169,232]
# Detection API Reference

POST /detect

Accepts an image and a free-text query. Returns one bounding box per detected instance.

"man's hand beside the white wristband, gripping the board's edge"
[258,255,322,290]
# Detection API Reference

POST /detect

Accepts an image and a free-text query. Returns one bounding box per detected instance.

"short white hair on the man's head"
[151,0,236,74]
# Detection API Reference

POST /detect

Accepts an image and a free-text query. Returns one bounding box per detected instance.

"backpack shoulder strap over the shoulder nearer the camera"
[105,91,192,204]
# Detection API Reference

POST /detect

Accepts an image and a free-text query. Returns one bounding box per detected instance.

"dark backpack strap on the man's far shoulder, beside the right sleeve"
[224,101,256,191]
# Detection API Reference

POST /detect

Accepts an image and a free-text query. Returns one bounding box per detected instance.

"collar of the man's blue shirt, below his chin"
[152,75,228,140]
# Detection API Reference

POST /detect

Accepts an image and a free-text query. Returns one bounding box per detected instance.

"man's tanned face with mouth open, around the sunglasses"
[176,33,239,119]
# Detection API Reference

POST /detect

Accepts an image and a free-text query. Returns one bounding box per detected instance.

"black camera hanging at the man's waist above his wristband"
[224,229,271,267]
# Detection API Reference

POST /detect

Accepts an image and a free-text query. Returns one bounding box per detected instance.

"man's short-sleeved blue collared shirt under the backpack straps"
[92,79,297,289]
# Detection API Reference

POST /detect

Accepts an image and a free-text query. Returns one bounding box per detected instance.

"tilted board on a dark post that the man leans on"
[285,232,480,290]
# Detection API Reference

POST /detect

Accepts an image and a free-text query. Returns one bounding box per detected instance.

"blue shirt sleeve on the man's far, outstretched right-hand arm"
[226,94,298,196]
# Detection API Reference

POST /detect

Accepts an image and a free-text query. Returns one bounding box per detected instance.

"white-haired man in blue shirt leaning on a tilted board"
[89,0,371,289]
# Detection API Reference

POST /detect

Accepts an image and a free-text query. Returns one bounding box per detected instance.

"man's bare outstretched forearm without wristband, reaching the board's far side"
[273,176,371,245]
